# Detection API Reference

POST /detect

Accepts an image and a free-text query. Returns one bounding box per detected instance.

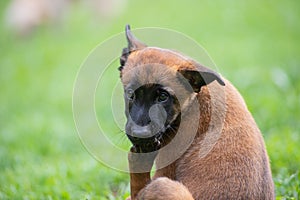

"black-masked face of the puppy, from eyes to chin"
[125,83,180,152]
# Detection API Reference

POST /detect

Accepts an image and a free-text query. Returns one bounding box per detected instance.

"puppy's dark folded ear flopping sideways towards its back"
[178,65,225,93]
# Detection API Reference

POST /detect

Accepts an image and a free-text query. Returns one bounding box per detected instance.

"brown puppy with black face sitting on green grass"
[119,26,275,200]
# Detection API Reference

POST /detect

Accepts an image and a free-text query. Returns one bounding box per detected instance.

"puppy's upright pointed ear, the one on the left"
[119,25,147,71]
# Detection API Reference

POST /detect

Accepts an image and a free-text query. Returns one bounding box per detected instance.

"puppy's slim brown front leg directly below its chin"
[128,146,157,200]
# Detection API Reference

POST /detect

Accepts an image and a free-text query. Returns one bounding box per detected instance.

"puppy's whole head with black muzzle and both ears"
[119,25,224,152]
